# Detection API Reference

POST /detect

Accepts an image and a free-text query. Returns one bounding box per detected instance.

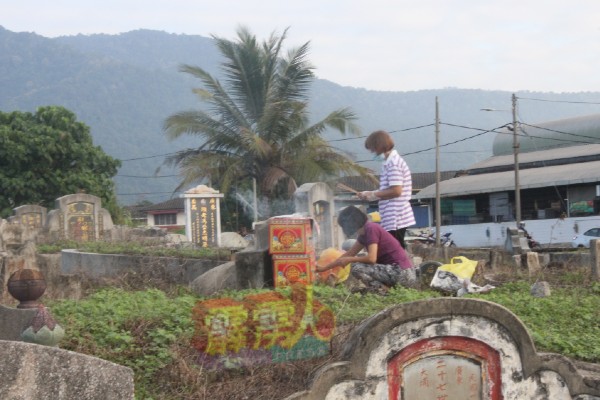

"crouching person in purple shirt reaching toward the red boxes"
[317,206,417,293]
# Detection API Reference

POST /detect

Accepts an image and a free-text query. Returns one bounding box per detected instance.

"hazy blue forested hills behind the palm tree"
[0,27,600,204]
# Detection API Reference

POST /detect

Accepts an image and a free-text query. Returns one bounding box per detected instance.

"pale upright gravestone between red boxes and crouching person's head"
[294,182,341,254]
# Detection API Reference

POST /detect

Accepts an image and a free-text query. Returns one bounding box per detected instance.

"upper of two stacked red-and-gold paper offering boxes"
[269,217,313,254]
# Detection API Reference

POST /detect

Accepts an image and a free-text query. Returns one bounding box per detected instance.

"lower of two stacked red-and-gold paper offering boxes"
[273,253,315,287]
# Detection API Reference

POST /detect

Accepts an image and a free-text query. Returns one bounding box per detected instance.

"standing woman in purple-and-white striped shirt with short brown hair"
[358,131,415,249]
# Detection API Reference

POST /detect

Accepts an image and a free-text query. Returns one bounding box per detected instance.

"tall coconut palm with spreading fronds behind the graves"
[165,27,368,214]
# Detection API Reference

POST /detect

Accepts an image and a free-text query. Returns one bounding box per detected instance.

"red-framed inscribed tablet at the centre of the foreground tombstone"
[388,336,502,400]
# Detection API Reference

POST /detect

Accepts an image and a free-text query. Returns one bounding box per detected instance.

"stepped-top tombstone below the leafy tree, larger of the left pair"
[47,193,113,241]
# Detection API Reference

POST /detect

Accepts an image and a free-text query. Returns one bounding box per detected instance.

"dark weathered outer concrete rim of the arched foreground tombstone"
[287,298,600,400]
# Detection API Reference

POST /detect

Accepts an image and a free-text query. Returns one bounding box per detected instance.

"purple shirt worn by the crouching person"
[356,222,412,269]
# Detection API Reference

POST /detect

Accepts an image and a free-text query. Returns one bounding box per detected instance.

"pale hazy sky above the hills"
[0,0,600,92]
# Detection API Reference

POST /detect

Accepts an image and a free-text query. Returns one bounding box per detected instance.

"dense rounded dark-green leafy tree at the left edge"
[0,106,121,217]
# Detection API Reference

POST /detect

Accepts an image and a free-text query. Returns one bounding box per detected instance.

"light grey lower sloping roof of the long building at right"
[414,159,600,199]
